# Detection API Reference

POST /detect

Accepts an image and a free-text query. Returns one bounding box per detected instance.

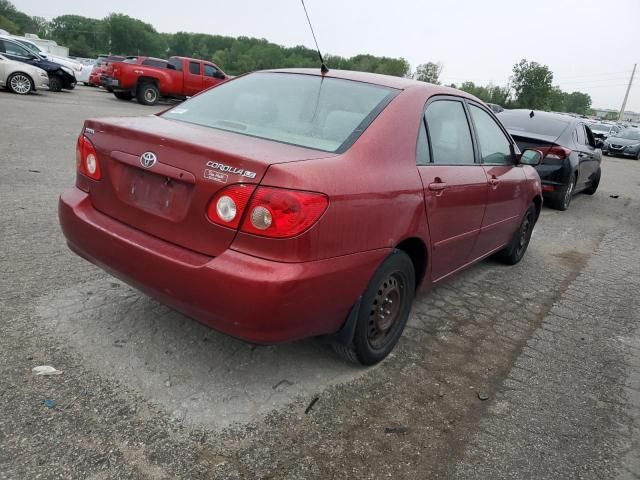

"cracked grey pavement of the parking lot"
[0,87,640,479]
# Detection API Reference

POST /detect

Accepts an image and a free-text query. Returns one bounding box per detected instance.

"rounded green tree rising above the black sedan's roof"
[511,59,553,110]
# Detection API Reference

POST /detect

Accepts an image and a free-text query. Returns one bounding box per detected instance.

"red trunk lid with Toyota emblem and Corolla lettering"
[84,116,334,256]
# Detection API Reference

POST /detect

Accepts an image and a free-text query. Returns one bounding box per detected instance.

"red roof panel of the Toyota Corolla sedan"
[262,68,483,96]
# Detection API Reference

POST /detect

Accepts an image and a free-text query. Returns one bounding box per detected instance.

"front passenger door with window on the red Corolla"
[468,102,527,259]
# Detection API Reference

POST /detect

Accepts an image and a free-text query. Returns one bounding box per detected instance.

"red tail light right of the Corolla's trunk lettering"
[241,187,329,238]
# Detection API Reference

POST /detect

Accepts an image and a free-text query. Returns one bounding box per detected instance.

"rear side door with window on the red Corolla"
[417,97,487,281]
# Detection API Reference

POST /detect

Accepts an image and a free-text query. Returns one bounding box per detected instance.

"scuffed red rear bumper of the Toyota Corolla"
[58,187,390,344]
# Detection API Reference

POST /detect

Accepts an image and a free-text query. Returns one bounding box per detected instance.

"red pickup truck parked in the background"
[109,57,228,105]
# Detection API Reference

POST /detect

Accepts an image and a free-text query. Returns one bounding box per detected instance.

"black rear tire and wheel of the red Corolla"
[333,250,416,365]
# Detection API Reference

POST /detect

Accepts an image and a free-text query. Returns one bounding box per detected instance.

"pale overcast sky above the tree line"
[13,0,640,112]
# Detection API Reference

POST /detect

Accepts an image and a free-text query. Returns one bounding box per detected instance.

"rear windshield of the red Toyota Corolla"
[163,72,398,152]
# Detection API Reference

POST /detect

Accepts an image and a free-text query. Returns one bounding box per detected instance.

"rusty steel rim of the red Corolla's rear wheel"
[367,273,406,350]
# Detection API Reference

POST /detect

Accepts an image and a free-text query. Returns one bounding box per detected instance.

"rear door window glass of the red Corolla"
[425,100,474,165]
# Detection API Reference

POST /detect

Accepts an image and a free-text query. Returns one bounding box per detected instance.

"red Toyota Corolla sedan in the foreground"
[59,70,542,364]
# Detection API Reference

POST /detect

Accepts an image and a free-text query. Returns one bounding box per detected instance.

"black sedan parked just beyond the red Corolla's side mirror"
[498,110,602,210]
